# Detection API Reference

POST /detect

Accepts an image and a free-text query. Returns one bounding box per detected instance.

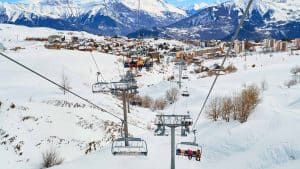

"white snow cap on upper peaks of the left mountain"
[0,0,187,22]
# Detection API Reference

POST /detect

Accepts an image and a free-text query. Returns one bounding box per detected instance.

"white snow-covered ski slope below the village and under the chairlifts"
[0,24,300,169]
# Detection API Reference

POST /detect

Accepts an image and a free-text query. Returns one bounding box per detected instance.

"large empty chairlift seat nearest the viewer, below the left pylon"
[111,137,148,156]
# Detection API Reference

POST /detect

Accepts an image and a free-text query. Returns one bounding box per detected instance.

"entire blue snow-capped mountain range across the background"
[0,0,300,40]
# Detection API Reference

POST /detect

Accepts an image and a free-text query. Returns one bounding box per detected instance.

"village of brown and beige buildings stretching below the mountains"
[21,33,300,67]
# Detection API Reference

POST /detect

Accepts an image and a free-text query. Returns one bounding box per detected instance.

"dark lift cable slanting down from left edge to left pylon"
[0,52,145,130]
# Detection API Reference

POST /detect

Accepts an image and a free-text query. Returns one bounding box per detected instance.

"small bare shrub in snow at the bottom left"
[43,149,64,168]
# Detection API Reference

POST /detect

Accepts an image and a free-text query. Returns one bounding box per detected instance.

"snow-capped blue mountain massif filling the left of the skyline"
[0,0,187,35]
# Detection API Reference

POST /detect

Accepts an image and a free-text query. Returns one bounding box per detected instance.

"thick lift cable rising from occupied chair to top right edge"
[192,0,253,130]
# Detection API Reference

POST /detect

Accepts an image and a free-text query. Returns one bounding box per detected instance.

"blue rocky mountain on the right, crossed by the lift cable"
[160,0,300,40]
